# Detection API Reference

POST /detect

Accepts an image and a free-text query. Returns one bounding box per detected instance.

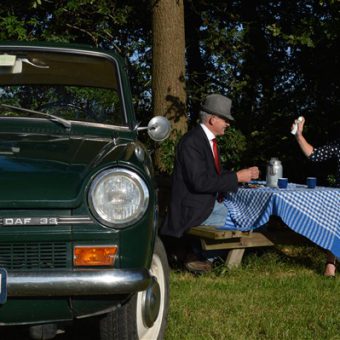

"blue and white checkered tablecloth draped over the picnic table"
[220,184,340,257]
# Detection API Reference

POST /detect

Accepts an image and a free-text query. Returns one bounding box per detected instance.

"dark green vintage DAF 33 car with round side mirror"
[0,43,170,339]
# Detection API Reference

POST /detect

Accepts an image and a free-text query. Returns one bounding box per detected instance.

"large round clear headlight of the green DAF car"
[88,168,149,227]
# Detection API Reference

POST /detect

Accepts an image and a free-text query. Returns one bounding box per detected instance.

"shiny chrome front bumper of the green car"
[7,269,151,297]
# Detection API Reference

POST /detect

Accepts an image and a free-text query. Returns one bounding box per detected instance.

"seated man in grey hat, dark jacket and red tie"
[161,94,259,272]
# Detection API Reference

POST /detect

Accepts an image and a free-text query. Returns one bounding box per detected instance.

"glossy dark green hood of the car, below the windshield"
[0,121,135,208]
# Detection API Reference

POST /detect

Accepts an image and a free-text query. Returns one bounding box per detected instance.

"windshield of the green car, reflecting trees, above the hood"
[0,50,126,125]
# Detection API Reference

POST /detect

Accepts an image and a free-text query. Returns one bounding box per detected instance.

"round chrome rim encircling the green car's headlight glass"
[87,167,150,229]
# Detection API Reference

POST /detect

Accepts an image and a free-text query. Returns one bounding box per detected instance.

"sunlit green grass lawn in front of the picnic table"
[165,247,340,340]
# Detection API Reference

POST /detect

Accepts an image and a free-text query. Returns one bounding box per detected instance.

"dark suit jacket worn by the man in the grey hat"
[161,125,238,237]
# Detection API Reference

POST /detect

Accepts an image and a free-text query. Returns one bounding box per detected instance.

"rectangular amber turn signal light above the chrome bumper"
[73,246,117,266]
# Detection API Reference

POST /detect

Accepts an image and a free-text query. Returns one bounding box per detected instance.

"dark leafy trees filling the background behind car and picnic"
[0,0,340,181]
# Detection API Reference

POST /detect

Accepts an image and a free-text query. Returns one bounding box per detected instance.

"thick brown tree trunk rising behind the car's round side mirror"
[151,0,187,134]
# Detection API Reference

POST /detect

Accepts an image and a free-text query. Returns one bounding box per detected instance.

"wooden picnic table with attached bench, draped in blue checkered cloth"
[189,182,340,267]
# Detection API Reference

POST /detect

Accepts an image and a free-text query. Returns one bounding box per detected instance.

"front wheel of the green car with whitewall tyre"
[99,238,169,340]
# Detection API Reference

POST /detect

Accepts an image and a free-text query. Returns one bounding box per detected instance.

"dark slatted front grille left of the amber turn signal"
[0,242,70,270]
